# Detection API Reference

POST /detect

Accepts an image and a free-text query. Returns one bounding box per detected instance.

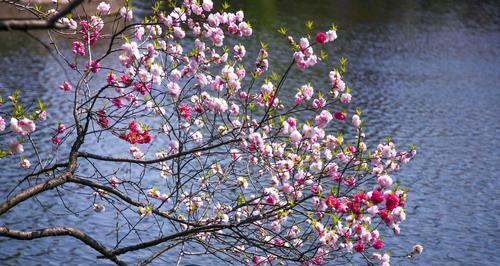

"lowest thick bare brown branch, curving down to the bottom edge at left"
[0,227,127,265]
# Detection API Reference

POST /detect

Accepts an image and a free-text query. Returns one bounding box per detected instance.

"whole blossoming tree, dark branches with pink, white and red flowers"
[0,0,422,265]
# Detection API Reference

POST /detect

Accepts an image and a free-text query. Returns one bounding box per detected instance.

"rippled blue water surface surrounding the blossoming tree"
[0,0,500,265]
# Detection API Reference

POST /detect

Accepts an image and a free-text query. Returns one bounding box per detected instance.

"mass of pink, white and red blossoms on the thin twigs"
[0,0,421,265]
